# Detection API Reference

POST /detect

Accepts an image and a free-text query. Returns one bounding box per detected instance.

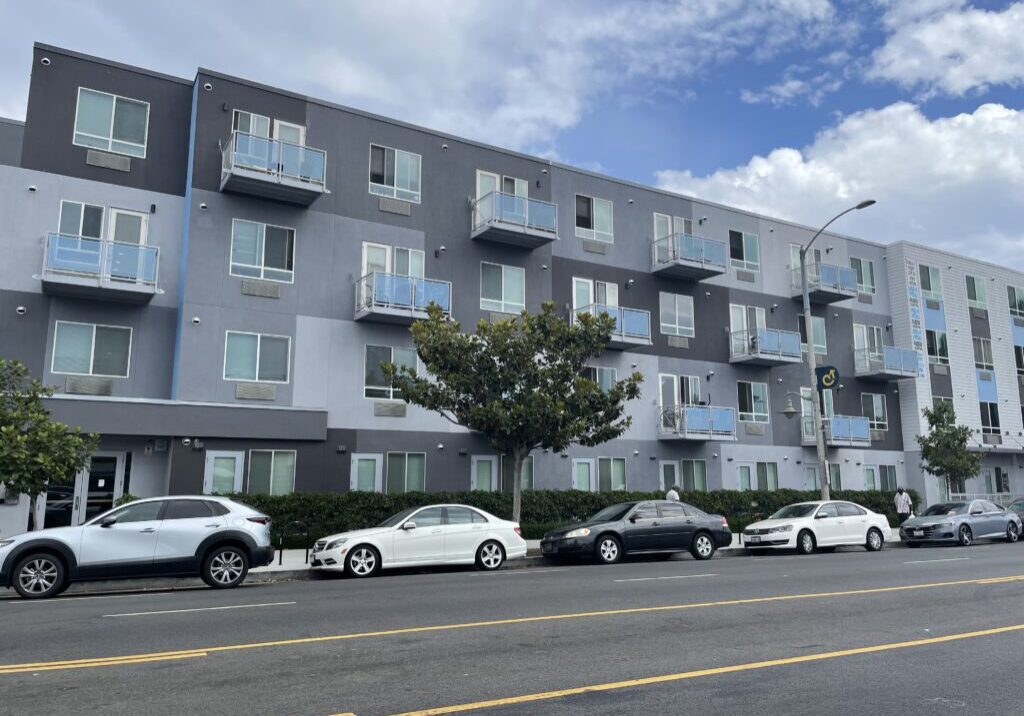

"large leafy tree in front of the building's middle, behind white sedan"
[384,302,643,521]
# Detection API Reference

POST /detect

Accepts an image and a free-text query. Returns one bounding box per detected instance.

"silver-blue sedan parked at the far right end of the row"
[899,500,1021,547]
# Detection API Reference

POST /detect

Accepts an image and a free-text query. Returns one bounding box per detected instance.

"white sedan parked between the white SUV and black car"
[311,505,526,577]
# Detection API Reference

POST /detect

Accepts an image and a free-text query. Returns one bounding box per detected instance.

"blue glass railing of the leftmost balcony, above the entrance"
[43,234,160,286]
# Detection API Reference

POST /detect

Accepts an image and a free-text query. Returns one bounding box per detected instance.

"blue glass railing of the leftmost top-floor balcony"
[222,131,327,192]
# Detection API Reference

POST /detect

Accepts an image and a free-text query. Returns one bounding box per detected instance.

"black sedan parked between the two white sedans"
[541,500,732,564]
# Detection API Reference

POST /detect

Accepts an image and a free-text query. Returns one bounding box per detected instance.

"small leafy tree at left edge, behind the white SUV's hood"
[0,359,99,529]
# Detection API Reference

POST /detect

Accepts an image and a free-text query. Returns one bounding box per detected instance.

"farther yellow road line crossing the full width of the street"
[0,575,1024,675]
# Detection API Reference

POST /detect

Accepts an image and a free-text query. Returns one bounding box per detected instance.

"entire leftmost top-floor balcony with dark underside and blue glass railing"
[220,131,327,206]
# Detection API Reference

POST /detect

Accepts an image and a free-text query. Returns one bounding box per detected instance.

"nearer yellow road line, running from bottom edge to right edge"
[385,624,1024,716]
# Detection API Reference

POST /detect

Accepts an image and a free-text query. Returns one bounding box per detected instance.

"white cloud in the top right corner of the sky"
[867,0,1024,97]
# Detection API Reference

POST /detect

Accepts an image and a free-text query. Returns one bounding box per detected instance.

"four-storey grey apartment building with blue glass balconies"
[0,44,1024,530]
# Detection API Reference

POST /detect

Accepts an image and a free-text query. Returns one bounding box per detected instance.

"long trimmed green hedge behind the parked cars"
[230,490,921,548]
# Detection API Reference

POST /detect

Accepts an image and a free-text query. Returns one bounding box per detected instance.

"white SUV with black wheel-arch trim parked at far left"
[0,496,273,599]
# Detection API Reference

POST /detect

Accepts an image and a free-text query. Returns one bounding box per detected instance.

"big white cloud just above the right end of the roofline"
[657,102,1024,268]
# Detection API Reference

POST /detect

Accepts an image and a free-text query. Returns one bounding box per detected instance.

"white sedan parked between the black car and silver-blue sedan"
[743,500,890,554]
